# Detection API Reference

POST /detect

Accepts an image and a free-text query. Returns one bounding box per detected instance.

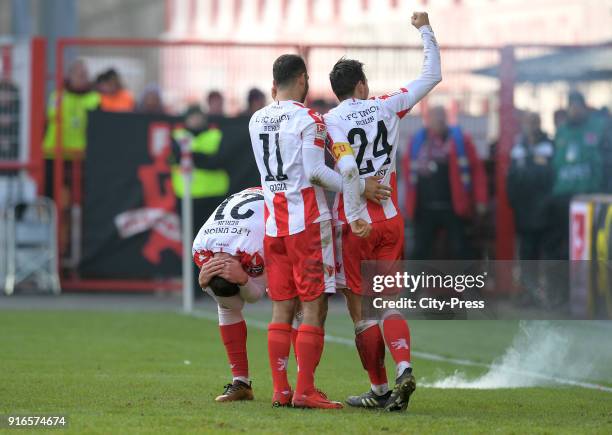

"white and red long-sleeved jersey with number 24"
[325,26,442,222]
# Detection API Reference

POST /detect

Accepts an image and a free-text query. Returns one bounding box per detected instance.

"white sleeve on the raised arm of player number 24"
[380,26,442,118]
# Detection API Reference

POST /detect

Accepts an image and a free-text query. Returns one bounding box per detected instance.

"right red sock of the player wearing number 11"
[295,324,325,394]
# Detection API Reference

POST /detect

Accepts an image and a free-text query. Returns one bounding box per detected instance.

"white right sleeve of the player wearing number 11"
[302,123,342,192]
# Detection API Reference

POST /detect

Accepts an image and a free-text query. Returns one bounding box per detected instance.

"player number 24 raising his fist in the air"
[325,12,442,411]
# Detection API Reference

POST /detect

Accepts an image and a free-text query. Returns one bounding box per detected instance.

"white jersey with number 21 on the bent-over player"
[191,187,264,276]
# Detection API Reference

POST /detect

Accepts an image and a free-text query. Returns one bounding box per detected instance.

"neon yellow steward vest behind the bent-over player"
[172,128,230,199]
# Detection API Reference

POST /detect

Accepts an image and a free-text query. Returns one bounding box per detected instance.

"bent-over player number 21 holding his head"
[192,188,266,402]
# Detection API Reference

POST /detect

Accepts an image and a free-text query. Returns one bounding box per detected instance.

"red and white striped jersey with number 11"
[249,101,331,237]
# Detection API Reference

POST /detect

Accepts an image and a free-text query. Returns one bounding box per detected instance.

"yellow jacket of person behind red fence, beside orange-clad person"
[43,90,100,159]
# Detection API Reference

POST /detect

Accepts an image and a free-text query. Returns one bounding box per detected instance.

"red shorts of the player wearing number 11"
[264,220,336,302]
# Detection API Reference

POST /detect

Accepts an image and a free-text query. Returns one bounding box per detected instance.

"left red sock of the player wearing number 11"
[268,323,291,392]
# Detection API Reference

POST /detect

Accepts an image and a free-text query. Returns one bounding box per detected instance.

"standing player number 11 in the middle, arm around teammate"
[249,54,369,408]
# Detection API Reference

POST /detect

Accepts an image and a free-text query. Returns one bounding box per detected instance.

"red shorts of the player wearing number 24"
[336,214,404,294]
